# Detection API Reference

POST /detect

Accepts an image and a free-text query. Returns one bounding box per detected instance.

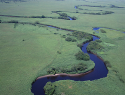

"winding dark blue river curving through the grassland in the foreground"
[31,36,108,95]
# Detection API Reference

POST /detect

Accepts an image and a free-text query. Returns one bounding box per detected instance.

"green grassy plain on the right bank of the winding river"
[54,29,125,95]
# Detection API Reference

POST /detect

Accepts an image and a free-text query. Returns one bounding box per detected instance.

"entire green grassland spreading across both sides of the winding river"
[0,0,125,95]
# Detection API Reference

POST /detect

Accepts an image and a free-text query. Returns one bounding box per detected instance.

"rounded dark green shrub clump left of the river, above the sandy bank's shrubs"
[75,51,90,61]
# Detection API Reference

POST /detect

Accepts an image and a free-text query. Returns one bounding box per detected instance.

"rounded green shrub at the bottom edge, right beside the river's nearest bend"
[44,82,55,95]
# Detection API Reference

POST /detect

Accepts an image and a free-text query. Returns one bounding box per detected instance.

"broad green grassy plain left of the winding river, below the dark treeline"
[0,23,94,95]
